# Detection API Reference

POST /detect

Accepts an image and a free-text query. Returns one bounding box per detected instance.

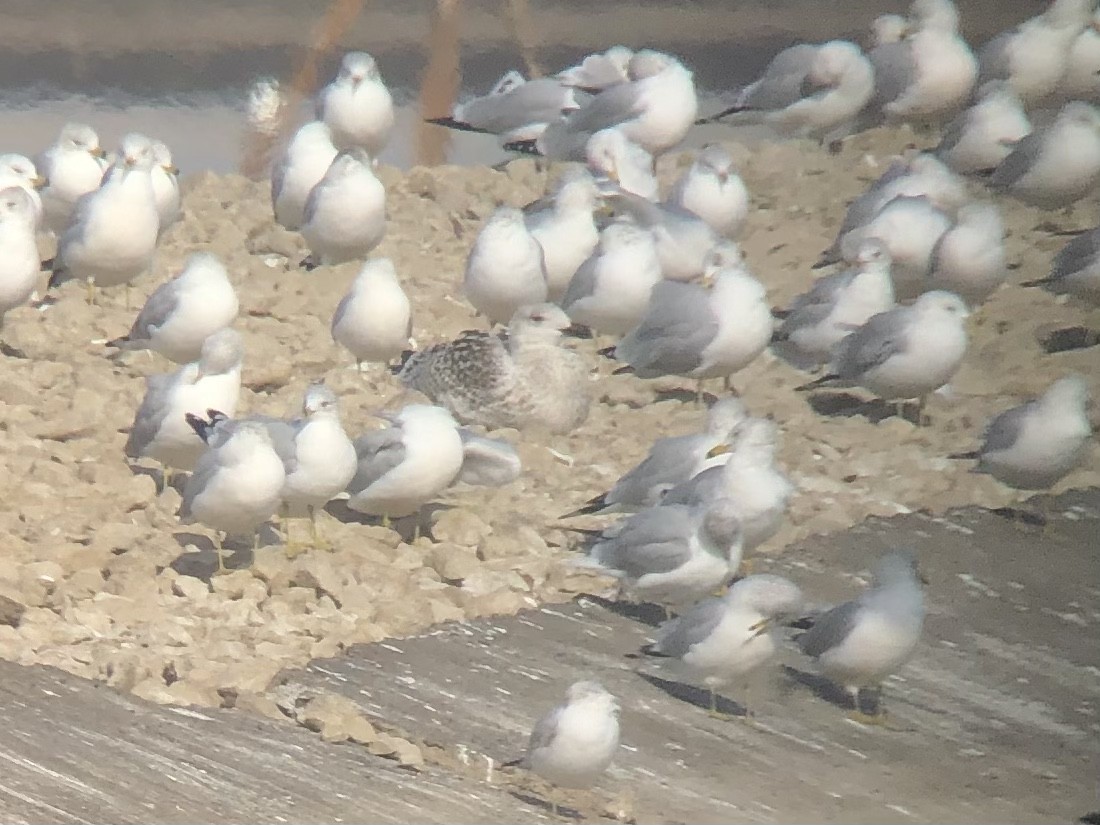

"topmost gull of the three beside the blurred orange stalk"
[317,52,394,157]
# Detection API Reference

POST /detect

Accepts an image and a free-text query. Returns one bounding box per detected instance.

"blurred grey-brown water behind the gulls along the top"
[0,0,1041,172]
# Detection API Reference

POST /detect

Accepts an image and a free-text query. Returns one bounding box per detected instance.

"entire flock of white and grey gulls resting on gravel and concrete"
[0,0,1100,805]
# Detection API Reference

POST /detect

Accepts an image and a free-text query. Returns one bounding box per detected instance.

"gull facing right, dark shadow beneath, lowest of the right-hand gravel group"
[798,289,970,422]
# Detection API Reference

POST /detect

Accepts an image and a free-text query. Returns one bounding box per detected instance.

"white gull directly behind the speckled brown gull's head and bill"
[560,221,662,336]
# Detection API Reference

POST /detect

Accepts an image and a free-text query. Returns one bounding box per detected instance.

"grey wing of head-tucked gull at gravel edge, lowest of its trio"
[592,507,695,579]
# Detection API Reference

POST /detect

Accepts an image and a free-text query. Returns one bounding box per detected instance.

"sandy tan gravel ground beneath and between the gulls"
[0,125,1100,721]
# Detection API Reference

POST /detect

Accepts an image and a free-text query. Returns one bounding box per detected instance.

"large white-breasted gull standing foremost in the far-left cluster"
[50,133,161,303]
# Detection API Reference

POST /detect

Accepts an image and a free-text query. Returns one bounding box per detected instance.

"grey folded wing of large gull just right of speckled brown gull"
[615,281,718,378]
